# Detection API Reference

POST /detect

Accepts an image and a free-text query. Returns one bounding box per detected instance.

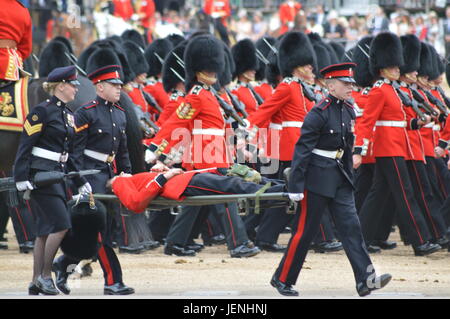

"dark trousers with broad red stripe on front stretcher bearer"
[275,186,374,285]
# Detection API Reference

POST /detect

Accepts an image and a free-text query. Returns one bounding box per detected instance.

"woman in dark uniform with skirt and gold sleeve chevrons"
[14,66,91,295]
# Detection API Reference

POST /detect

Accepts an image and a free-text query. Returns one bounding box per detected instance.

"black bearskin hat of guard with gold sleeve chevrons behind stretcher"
[184,35,224,91]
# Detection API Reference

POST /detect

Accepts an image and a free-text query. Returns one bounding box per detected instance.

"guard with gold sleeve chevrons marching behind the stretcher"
[146,35,260,257]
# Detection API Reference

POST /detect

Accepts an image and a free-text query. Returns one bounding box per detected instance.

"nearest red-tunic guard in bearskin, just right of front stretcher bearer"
[353,32,440,256]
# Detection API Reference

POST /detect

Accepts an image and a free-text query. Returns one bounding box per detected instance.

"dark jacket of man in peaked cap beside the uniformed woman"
[74,96,131,173]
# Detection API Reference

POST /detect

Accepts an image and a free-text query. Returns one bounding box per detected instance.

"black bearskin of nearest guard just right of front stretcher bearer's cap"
[369,32,404,76]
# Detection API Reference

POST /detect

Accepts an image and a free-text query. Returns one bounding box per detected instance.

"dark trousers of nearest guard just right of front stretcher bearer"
[359,157,431,246]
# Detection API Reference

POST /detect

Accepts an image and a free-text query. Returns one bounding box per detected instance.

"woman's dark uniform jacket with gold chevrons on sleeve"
[14,96,86,186]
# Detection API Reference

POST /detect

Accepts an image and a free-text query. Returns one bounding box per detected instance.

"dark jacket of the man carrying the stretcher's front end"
[288,95,356,198]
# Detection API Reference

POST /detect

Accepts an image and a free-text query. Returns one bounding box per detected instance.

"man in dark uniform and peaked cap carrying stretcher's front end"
[271,63,391,296]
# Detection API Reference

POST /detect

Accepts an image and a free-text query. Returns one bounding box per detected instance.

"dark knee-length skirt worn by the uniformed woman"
[30,183,72,237]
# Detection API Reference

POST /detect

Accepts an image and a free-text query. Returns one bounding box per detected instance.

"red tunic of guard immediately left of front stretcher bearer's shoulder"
[248,77,314,161]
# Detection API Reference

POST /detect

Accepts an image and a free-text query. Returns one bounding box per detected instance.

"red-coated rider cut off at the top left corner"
[0,0,32,81]
